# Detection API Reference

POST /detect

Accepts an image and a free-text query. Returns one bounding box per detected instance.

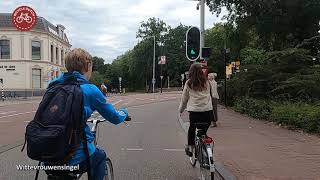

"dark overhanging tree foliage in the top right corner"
[207,0,320,51]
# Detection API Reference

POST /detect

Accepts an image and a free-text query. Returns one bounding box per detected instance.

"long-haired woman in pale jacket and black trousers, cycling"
[179,63,218,156]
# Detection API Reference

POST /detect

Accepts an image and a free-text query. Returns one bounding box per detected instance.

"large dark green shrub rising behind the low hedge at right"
[227,49,320,104]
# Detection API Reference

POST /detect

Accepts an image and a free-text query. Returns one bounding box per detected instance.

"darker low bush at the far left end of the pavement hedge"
[234,97,271,120]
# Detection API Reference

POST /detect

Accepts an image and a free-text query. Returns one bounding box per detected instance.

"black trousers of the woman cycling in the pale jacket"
[188,110,214,145]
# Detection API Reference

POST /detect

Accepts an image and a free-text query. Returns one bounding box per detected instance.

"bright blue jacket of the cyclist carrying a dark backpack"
[50,71,128,165]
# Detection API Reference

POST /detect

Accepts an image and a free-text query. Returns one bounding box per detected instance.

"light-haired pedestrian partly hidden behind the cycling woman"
[208,73,219,127]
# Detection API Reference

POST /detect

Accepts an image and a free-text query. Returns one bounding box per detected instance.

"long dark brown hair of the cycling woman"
[187,63,207,91]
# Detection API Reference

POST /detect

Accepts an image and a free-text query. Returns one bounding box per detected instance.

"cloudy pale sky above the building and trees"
[0,0,226,63]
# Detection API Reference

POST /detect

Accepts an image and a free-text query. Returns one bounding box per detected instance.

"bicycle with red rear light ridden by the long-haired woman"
[186,123,215,180]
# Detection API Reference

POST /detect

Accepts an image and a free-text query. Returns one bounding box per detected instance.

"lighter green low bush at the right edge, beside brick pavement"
[270,103,320,133]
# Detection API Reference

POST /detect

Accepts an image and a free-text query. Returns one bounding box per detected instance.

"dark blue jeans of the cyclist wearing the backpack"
[79,148,107,180]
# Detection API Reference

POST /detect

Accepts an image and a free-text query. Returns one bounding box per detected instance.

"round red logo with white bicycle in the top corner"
[12,6,37,31]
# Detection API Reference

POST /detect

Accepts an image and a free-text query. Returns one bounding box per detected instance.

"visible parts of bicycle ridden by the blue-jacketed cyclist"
[47,116,131,180]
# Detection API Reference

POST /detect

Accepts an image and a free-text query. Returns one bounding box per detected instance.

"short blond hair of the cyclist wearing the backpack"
[65,48,92,72]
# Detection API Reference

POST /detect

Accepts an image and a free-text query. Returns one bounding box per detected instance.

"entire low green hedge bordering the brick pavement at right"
[233,97,320,134]
